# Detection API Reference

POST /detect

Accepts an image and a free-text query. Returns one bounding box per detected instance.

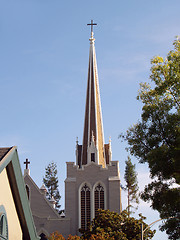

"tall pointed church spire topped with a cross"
[76,20,111,167]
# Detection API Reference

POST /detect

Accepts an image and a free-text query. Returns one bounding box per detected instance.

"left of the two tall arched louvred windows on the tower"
[81,184,91,230]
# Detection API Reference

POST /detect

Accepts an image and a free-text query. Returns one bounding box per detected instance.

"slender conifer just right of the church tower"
[124,156,139,215]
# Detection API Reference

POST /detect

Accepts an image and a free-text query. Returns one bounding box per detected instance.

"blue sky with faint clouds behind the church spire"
[0,0,180,240]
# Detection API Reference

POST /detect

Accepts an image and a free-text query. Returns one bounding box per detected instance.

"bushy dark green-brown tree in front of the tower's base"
[80,209,155,240]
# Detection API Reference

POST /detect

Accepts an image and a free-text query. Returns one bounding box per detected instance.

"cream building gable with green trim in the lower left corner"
[0,147,38,240]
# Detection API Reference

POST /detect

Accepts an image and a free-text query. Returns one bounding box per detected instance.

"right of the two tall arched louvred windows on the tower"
[94,184,104,216]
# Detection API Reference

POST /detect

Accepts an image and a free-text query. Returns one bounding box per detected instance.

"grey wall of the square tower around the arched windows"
[65,161,121,234]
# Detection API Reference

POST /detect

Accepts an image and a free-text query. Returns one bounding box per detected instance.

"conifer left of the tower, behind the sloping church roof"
[43,162,61,211]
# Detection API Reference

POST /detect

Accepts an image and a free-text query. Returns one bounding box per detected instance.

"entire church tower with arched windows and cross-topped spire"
[65,21,121,234]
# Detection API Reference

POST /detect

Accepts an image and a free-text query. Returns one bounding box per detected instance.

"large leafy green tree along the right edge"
[121,40,180,239]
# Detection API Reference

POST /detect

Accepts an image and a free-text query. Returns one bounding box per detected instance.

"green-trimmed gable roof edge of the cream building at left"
[0,146,39,240]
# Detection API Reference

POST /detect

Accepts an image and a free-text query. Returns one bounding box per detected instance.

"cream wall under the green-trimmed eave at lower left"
[0,169,22,240]
